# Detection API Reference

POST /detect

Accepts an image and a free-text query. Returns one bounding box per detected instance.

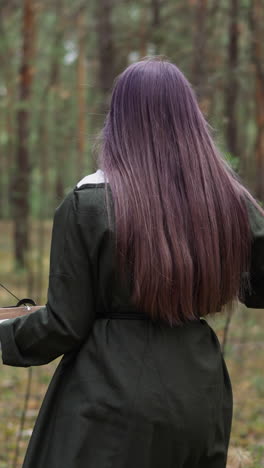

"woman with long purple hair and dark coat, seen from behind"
[0,56,264,468]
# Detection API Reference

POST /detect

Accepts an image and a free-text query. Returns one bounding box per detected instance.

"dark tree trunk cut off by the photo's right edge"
[250,0,264,201]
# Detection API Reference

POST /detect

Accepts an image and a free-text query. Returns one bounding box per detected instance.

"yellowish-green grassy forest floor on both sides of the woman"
[0,221,264,468]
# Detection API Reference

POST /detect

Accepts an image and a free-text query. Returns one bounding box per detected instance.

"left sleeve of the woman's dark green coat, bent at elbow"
[0,189,95,367]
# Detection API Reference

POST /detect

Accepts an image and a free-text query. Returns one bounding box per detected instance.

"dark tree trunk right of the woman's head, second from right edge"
[225,0,239,156]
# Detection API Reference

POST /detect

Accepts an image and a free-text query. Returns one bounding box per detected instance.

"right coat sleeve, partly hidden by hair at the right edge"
[239,199,264,309]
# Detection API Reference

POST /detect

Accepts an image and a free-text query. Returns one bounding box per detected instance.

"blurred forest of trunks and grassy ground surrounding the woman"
[0,0,264,468]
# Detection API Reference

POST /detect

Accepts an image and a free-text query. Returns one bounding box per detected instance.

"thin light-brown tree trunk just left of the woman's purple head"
[76,8,87,180]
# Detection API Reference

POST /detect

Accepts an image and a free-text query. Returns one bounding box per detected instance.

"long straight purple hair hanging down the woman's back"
[99,56,262,326]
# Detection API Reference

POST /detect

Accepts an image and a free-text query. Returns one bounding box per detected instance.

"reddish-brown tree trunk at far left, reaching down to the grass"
[13,0,35,268]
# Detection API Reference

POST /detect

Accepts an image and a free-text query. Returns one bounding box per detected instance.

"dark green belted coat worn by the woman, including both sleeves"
[0,183,264,468]
